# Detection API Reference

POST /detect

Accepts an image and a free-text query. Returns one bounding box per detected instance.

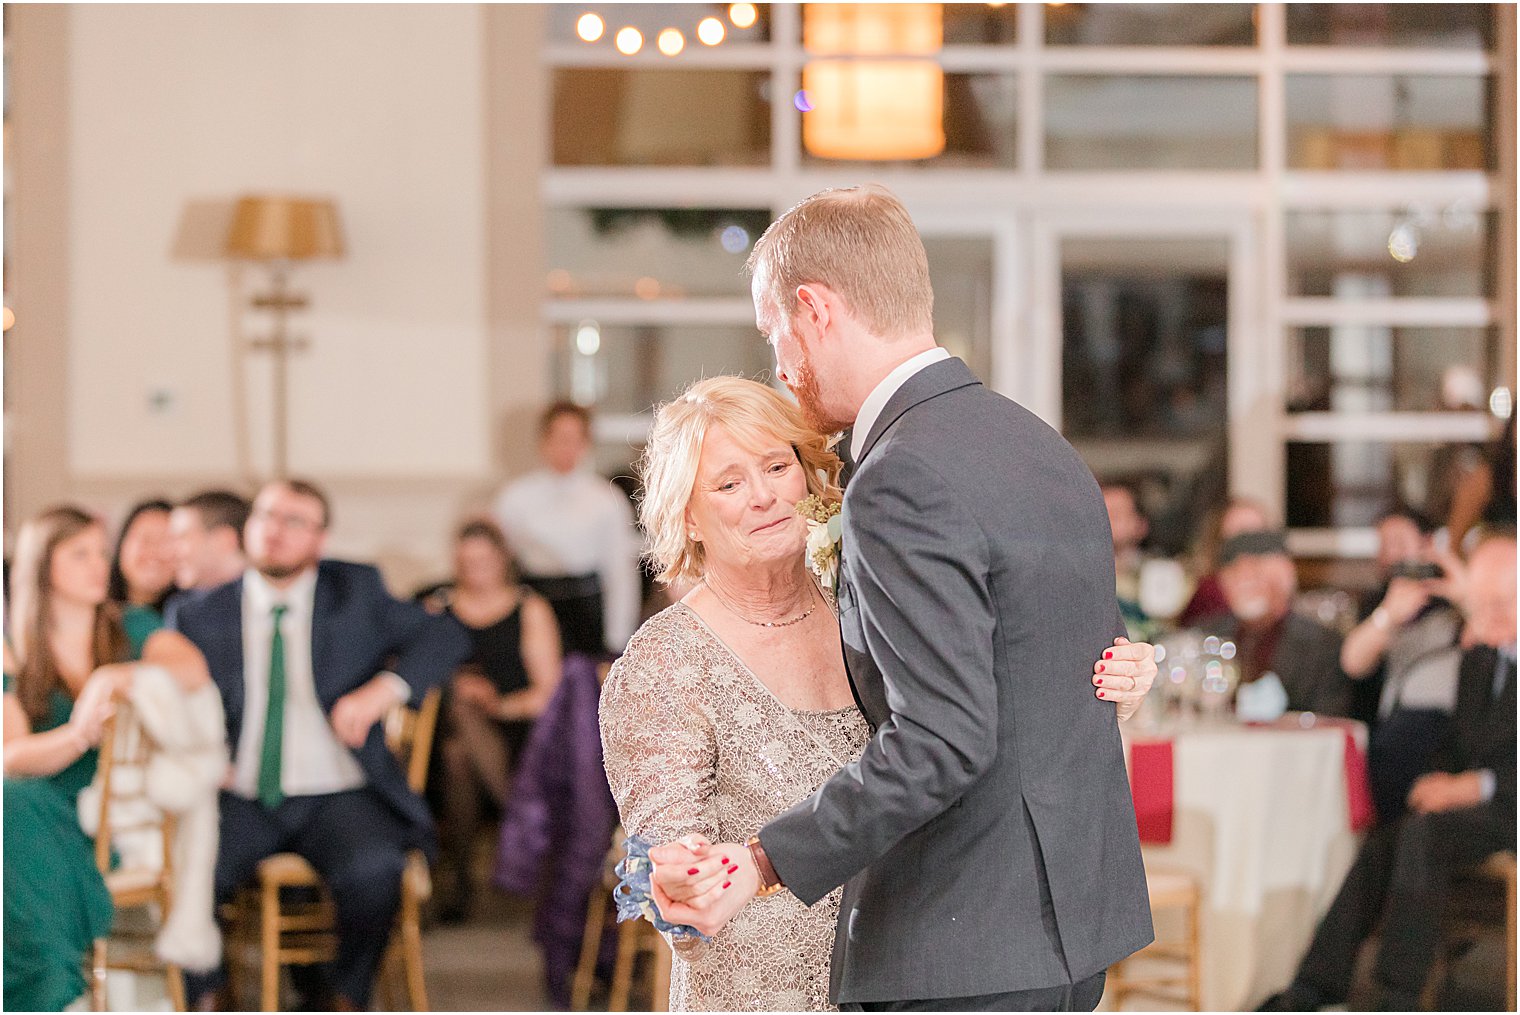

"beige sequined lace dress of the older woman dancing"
[602,603,871,1012]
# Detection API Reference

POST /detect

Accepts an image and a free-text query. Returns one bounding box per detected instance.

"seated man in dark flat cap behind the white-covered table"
[1201,532,1351,716]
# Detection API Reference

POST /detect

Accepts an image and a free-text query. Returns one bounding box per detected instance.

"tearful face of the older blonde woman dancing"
[686,427,807,568]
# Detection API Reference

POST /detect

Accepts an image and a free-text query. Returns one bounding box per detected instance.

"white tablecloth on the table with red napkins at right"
[1134,726,1366,1010]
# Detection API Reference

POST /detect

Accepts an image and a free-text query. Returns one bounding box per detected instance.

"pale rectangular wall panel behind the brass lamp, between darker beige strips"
[68,5,488,476]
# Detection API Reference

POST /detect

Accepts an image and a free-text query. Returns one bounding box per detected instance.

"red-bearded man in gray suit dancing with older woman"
[657,185,1152,1010]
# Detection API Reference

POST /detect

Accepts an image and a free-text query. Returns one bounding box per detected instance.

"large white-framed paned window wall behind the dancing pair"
[543,3,1515,556]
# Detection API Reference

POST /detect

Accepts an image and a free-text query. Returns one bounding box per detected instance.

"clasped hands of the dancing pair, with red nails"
[649,836,760,936]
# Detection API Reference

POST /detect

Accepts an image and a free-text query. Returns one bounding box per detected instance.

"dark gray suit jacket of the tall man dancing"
[760,359,1152,1003]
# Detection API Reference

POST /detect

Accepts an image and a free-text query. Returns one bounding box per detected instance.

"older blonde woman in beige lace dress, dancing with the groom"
[602,377,1155,1010]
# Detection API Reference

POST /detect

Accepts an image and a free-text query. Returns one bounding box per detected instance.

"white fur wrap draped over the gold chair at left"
[79,664,228,971]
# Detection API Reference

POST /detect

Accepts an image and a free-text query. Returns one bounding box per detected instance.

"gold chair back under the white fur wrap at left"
[94,702,175,881]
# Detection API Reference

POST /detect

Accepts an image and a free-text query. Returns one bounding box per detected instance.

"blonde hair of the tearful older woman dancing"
[638,377,841,585]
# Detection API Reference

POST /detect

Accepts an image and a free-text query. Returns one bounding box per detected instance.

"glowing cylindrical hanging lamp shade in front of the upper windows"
[803,3,945,161]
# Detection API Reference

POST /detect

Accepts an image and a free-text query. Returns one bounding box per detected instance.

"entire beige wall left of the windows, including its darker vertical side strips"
[6,5,547,585]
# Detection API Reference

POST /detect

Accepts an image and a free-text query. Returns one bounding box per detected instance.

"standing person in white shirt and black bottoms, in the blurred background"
[492,401,640,656]
